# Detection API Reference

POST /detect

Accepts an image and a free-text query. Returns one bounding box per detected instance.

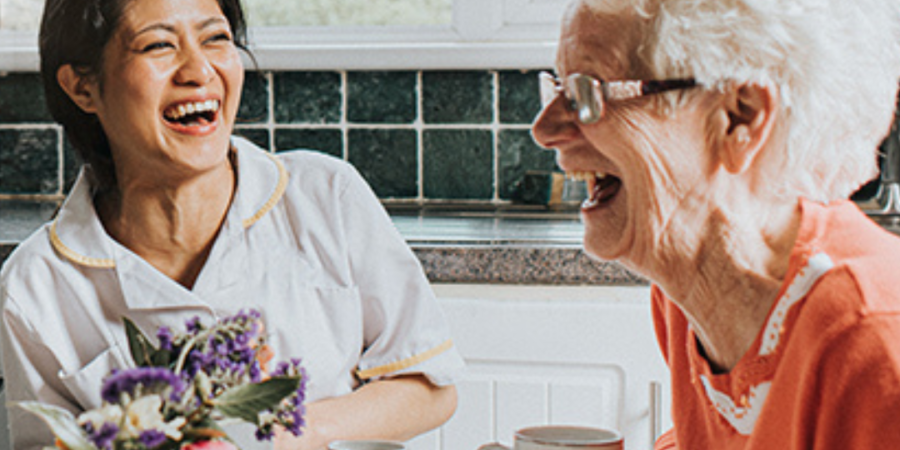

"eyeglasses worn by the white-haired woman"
[539,72,697,125]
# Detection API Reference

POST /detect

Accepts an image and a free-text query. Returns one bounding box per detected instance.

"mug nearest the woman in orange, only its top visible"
[479,425,625,450]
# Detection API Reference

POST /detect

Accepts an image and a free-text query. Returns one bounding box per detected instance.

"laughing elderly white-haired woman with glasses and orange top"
[533,0,900,450]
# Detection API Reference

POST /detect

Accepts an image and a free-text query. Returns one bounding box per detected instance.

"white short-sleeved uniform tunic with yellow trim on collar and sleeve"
[0,138,463,449]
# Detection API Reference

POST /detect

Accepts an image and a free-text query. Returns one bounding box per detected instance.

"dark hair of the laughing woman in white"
[40,0,247,192]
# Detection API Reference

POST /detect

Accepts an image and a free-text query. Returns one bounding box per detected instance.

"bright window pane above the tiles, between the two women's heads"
[244,0,453,27]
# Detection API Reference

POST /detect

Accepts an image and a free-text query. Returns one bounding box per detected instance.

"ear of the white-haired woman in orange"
[718,84,779,174]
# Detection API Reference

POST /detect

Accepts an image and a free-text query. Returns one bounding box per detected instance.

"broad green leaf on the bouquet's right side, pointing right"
[213,377,300,425]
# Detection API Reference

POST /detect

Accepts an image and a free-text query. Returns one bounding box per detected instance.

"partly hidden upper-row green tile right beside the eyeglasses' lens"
[498,70,541,124]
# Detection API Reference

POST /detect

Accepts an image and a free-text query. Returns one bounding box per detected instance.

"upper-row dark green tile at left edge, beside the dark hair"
[0,73,53,123]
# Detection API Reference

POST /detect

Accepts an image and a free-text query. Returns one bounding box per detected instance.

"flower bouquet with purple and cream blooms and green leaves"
[19,310,306,450]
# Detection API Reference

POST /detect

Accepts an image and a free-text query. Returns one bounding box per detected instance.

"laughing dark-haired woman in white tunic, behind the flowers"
[0,0,462,449]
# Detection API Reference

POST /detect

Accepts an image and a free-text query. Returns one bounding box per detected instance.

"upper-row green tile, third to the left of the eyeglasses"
[347,71,416,124]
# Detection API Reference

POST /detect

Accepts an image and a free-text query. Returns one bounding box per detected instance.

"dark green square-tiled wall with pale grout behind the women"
[0,70,556,204]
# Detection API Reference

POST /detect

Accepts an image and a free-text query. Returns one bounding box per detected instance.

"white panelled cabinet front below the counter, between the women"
[410,285,670,450]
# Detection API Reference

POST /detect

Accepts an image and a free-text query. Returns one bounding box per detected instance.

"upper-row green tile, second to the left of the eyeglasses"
[422,71,494,124]
